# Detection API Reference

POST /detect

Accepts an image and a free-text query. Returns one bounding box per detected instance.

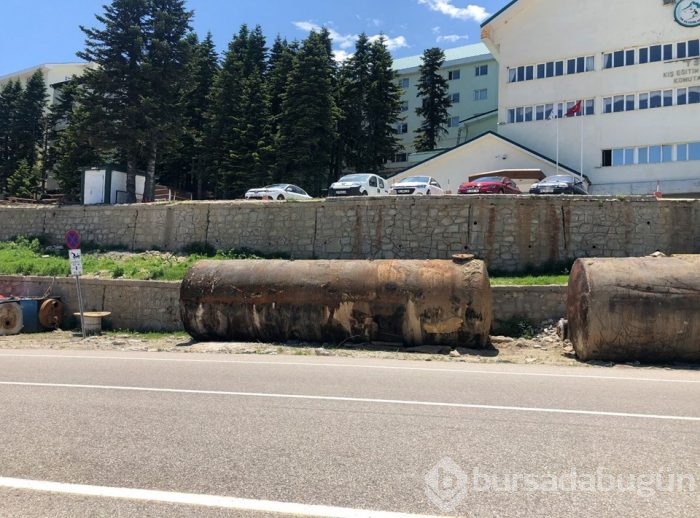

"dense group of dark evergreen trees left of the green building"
[0,0,412,201]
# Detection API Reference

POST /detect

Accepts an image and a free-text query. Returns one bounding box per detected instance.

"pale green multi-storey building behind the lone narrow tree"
[387,43,498,168]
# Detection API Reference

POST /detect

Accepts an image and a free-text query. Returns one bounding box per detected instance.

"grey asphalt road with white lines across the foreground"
[0,350,700,517]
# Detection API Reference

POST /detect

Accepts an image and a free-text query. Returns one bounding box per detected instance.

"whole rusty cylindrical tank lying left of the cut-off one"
[180,260,491,348]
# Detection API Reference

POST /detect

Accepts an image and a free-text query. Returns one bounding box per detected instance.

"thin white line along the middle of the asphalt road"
[0,381,700,422]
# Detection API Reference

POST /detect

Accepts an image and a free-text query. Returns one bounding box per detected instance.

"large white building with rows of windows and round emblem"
[482,0,700,195]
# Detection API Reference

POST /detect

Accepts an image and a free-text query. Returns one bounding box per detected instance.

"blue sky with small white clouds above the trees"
[0,0,508,75]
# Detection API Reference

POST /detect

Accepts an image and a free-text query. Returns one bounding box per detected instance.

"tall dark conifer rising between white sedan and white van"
[276,29,337,195]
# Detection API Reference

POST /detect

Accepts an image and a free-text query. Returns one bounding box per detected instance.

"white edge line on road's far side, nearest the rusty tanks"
[0,353,700,383]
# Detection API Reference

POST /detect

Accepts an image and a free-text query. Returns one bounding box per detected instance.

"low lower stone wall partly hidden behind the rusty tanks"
[0,276,566,331]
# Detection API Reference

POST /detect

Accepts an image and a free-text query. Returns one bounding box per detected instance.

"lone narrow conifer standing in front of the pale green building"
[414,47,452,151]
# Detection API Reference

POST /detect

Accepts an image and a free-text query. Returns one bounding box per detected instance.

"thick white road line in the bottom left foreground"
[0,477,446,518]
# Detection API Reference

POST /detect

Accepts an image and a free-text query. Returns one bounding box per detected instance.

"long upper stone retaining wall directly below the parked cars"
[0,195,700,272]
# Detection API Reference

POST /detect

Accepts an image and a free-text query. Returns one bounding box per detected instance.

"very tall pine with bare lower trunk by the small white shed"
[78,0,149,202]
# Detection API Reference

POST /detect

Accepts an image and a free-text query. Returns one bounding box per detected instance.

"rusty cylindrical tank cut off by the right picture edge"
[566,255,700,362]
